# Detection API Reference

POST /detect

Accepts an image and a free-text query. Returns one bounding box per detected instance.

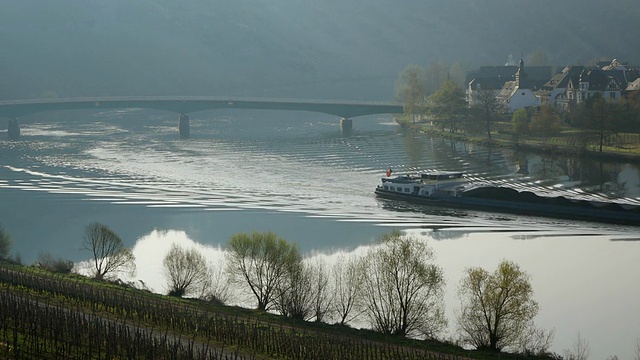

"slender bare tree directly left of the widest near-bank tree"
[331,256,362,325]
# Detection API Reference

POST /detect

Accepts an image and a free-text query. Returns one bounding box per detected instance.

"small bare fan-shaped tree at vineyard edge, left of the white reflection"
[82,222,136,279]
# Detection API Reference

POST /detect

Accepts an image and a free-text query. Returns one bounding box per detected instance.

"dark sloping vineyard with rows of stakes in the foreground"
[0,264,484,360]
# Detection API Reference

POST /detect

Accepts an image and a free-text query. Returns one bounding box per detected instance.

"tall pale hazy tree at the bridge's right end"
[396,65,426,122]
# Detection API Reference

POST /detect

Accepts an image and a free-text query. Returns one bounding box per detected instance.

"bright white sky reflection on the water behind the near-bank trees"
[112,229,640,359]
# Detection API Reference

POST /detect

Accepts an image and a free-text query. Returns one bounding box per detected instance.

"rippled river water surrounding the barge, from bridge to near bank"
[0,110,640,359]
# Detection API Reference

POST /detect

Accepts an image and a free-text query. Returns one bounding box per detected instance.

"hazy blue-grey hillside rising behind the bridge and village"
[0,0,640,100]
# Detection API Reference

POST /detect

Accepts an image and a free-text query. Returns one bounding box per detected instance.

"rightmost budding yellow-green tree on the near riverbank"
[457,260,539,351]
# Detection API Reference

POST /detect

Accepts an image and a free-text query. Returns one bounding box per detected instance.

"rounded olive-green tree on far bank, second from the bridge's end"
[429,80,467,132]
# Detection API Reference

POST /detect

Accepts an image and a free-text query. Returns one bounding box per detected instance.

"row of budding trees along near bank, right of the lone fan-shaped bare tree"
[159,231,553,354]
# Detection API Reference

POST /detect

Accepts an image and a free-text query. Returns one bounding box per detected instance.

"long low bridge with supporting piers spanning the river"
[0,96,402,139]
